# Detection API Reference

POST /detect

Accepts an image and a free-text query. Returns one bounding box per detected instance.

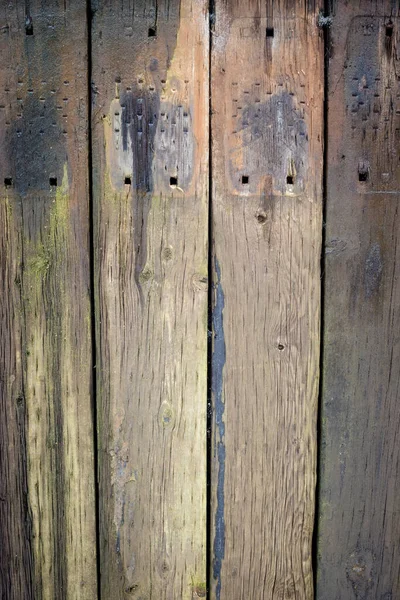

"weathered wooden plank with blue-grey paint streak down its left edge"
[211,0,323,600]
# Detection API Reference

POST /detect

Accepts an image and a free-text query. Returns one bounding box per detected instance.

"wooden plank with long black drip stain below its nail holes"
[92,0,208,600]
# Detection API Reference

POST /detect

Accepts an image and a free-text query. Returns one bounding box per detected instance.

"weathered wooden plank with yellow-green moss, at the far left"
[0,0,97,600]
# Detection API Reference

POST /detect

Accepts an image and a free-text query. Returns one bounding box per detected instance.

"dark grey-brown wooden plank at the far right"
[317,0,400,600]
